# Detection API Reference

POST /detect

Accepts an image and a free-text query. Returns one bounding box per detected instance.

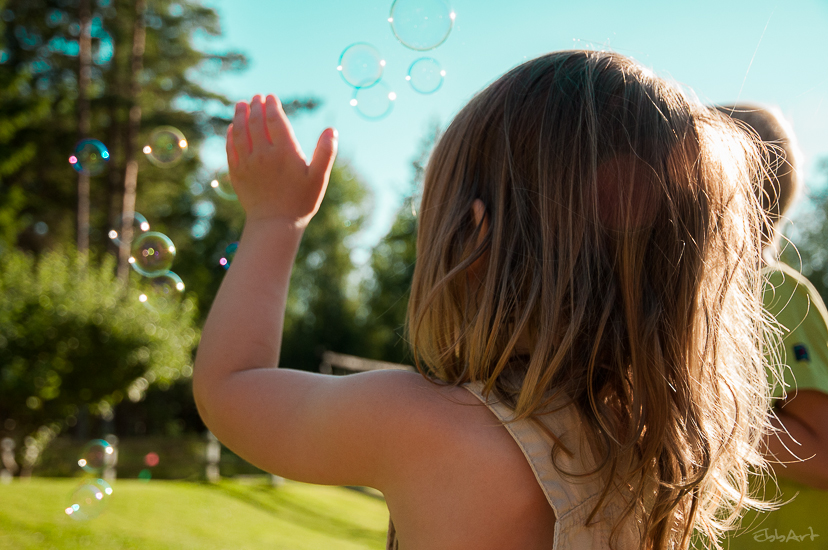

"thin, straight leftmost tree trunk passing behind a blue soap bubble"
[78,0,92,255]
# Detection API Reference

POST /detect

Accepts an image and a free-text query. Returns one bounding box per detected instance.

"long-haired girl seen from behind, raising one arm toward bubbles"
[193,51,768,550]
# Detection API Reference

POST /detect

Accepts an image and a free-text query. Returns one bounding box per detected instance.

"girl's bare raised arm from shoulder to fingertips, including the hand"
[193,96,450,490]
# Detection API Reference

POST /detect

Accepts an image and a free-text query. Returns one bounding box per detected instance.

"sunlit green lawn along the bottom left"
[0,478,388,550]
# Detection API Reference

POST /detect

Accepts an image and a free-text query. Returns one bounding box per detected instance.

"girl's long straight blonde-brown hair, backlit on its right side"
[407,51,769,548]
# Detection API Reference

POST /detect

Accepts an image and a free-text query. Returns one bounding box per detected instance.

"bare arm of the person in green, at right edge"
[767,390,828,490]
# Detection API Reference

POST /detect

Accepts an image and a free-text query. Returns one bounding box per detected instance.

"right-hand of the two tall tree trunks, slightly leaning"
[118,0,146,284]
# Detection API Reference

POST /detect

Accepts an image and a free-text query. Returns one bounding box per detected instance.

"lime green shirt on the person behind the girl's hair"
[724,264,828,550]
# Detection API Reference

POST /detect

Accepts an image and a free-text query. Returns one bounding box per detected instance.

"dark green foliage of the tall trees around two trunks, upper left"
[0,0,249,253]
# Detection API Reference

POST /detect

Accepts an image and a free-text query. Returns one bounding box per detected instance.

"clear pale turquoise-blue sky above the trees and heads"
[196,0,828,252]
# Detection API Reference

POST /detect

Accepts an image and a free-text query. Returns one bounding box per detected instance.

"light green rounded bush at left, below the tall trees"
[0,249,198,463]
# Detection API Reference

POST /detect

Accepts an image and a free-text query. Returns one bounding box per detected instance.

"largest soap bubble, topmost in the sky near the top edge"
[388,0,455,51]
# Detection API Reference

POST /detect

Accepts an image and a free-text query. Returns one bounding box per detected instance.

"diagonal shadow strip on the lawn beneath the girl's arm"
[202,482,385,545]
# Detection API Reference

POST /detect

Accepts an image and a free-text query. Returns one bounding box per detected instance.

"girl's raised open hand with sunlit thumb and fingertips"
[227,95,337,226]
